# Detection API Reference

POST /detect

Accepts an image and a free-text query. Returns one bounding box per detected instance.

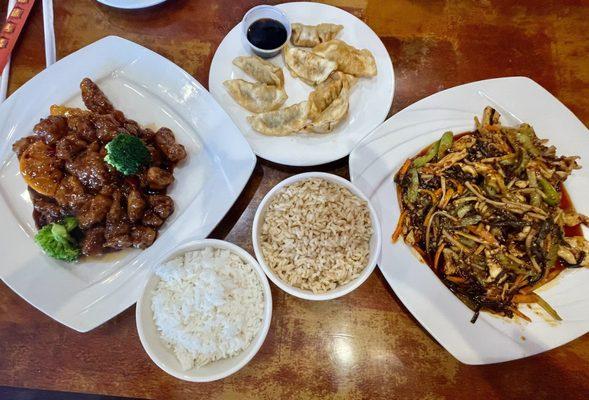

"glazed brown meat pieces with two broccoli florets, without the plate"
[13,78,186,261]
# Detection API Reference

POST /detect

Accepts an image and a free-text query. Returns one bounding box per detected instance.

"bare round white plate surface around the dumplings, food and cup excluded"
[209,2,395,166]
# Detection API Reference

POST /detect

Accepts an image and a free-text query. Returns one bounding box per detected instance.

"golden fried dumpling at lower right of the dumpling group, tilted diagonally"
[306,72,350,133]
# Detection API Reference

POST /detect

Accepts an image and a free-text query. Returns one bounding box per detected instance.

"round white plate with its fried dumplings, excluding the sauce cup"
[209,2,395,166]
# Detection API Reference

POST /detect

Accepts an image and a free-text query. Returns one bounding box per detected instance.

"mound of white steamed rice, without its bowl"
[151,247,264,370]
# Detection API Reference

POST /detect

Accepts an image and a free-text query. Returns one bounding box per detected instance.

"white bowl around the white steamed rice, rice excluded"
[135,239,272,382]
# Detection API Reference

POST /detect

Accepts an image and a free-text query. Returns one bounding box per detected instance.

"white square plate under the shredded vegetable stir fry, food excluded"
[350,77,589,364]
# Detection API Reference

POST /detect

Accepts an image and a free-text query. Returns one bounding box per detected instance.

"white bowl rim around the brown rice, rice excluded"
[252,172,382,300]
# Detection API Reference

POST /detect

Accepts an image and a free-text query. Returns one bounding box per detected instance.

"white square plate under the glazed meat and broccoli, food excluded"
[0,36,256,332]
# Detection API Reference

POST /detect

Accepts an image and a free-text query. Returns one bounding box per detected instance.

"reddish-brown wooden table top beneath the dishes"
[0,0,589,399]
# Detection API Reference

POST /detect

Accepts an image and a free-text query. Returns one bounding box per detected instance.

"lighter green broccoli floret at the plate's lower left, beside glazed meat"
[35,217,80,262]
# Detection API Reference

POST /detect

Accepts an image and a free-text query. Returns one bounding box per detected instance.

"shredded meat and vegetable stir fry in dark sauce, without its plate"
[392,107,589,323]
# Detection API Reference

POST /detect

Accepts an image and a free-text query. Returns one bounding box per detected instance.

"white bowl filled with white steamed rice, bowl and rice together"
[136,239,272,382]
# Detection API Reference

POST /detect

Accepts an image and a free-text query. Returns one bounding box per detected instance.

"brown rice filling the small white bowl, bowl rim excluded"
[260,178,373,293]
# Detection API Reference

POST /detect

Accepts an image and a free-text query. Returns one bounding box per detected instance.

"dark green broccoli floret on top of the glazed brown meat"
[104,133,151,175]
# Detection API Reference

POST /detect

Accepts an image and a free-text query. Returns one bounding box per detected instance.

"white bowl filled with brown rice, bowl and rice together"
[252,172,381,300]
